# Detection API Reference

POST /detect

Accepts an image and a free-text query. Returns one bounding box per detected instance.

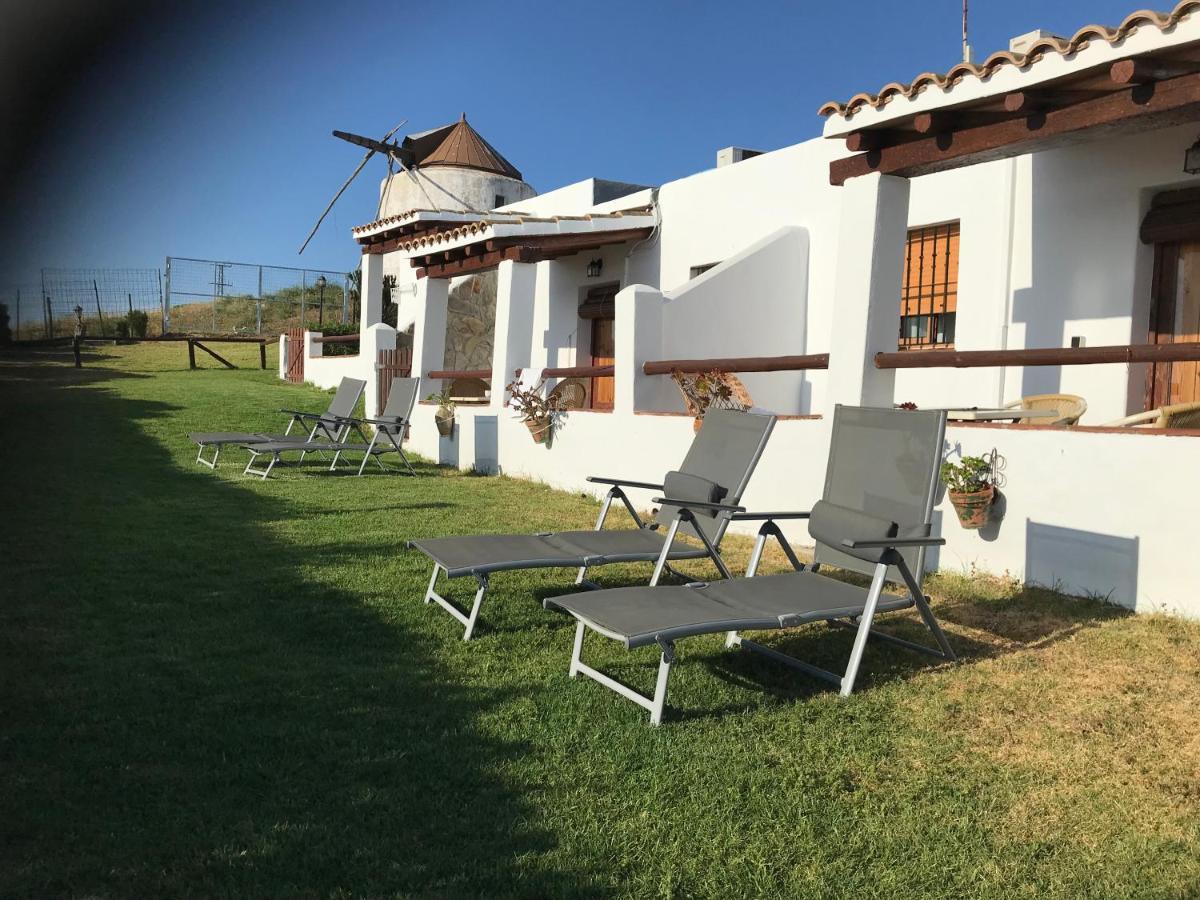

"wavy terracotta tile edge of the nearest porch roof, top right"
[817,0,1200,116]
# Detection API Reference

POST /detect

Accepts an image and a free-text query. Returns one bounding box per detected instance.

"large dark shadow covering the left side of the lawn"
[0,370,598,896]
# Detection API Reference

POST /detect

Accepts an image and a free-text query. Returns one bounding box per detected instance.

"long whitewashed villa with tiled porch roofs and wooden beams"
[290,0,1200,616]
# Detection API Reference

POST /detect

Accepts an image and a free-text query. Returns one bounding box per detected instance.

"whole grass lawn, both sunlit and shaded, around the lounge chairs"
[7,346,1200,898]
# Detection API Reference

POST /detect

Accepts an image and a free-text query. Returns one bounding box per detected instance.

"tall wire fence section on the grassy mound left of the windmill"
[164,257,359,335]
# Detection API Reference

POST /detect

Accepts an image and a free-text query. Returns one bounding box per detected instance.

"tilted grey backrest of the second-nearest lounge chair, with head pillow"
[655,409,775,546]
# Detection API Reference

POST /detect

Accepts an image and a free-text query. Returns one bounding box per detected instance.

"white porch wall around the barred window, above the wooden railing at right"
[896,120,1196,425]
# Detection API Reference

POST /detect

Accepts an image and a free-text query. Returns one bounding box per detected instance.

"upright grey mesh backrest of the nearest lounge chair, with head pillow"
[814,406,946,582]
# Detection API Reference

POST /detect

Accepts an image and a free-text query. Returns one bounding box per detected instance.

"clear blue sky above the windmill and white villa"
[0,0,1134,296]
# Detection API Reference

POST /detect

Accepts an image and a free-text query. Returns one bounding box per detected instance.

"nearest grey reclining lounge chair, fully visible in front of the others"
[545,407,955,725]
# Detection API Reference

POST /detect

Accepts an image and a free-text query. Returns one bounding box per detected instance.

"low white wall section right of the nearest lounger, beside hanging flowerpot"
[935,426,1200,617]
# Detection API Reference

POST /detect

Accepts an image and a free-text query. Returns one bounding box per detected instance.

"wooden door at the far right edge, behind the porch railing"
[1147,241,1200,408]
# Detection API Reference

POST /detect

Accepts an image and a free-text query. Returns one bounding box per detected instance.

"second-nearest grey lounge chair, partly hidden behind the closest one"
[408,409,775,641]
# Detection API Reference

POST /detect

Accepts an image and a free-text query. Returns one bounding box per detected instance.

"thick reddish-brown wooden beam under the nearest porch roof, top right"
[829,73,1200,185]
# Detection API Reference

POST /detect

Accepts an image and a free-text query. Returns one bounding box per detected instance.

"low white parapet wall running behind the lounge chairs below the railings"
[412,404,1200,617]
